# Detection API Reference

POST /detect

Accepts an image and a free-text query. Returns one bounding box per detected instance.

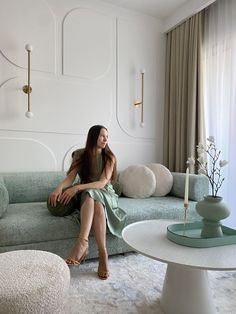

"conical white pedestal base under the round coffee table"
[161,264,216,314]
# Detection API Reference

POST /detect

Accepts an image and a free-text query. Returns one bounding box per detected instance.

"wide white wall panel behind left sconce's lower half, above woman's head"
[0,77,114,134]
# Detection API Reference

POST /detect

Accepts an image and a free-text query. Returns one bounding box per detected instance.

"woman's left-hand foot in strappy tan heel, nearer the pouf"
[65,238,88,265]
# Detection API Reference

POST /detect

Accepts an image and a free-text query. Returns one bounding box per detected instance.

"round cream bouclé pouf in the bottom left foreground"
[0,250,70,314]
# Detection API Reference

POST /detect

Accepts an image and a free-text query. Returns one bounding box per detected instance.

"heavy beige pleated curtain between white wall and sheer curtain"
[163,11,205,172]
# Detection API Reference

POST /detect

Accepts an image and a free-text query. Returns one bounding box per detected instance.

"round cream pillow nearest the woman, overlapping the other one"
[119,165,156,198]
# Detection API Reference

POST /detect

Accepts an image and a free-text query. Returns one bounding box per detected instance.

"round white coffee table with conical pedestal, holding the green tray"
[122,220,236,314]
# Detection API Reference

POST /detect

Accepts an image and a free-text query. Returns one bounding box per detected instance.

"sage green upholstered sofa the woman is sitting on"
[0,171,208,258]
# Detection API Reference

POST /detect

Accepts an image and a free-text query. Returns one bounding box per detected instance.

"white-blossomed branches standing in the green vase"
[187,136,228,197]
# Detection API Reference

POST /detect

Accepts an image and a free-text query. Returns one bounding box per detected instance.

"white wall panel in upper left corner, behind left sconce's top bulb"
[0,0,55,72]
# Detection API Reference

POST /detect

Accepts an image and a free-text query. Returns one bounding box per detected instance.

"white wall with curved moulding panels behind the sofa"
[0,0,165,172]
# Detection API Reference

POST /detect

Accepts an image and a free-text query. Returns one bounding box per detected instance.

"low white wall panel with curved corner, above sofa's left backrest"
[0,137,57,172]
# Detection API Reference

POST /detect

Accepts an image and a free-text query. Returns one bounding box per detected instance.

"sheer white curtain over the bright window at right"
[203,0,236,228]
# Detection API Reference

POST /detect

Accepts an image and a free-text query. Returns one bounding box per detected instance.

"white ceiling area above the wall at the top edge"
[103,0,189,19]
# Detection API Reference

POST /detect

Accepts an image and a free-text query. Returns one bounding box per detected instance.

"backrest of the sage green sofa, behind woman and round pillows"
[0,171,209,203]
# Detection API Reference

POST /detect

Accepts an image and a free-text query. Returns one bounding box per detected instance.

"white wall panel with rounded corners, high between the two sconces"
[63,8,114,79]
